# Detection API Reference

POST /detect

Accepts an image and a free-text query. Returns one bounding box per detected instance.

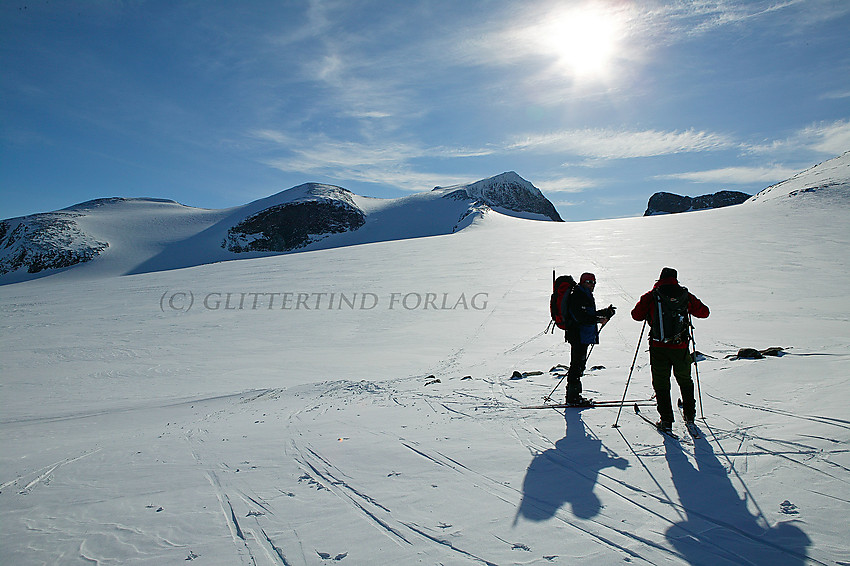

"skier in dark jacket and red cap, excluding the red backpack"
[561,273,615,406]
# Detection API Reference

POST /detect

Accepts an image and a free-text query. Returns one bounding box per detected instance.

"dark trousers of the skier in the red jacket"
[649,347,697,422]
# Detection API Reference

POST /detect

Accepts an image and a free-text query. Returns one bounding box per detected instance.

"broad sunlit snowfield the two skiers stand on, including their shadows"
[0,154,850,566]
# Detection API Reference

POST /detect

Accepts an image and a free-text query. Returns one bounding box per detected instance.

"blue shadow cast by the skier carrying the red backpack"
[514,409,629,523]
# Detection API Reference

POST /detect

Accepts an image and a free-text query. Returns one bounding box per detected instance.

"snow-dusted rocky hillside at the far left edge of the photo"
[0,212,109,275]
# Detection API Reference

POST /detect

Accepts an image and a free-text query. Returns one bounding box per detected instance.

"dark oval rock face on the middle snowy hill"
[222,185,366,253]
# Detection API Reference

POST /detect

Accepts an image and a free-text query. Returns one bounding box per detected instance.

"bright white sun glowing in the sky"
[538,4,623,79]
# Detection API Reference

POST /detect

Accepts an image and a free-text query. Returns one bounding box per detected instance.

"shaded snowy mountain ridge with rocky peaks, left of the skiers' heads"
[0,172,561,283]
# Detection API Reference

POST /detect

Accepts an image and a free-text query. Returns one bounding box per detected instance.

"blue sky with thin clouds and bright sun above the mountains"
[0,0,850,220]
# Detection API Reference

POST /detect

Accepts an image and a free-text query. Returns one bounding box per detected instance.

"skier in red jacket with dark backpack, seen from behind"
[632,267,709,431]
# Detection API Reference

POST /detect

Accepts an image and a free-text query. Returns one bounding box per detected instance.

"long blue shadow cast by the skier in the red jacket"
[664,437,811,566]
